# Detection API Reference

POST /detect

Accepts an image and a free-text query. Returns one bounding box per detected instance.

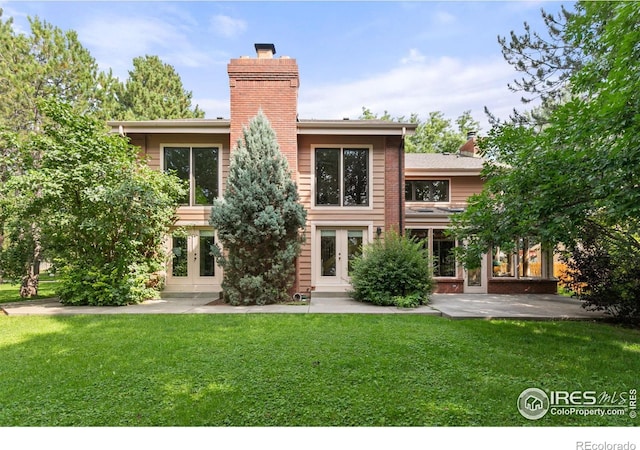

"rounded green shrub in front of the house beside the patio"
[351,231,433,307]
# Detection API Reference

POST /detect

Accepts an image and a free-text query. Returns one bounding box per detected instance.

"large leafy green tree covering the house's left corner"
[0,102,184,305]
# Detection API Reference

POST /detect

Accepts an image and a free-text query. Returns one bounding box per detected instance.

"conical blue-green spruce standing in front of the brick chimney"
[210,112,306,305]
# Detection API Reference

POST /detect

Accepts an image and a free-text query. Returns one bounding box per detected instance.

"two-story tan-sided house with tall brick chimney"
[109,44,556,295]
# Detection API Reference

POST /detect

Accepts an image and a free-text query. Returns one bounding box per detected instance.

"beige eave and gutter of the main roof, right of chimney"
[297,120,418,136]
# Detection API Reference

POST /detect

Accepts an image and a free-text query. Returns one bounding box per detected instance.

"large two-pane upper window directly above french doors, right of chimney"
[315,147,370,206]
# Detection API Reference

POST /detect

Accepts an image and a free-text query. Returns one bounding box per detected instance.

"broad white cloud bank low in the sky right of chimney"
[298,51,520,131]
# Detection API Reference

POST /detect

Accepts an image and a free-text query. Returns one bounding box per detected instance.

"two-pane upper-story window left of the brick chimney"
[163,146,220,206]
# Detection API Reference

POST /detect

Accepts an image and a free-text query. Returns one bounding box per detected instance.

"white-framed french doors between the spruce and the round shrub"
[315,227,367,290]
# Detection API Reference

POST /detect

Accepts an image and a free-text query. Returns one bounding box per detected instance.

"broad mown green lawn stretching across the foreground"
[0,314,640,426]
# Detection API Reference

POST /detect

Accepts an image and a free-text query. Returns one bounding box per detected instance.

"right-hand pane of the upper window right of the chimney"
[343,148,369,206]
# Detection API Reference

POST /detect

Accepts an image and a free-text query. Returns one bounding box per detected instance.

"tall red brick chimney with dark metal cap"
[227,44,299,179]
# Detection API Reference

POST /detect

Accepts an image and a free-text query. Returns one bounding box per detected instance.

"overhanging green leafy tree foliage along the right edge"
[453,2,640,322]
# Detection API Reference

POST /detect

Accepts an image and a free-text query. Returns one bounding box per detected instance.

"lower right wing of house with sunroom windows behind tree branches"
[405,138,557,294]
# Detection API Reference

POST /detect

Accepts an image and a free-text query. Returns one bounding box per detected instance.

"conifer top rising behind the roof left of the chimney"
[122,55,204,120]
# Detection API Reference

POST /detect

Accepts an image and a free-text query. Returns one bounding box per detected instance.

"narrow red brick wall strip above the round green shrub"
[384,138,404,232]
